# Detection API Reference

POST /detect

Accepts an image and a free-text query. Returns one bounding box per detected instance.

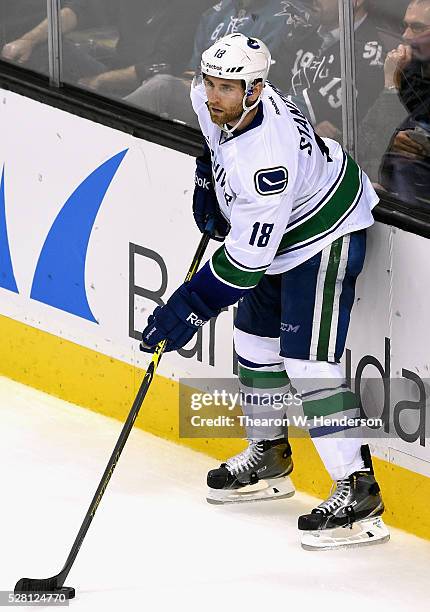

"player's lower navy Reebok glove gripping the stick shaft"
[139,284,219,353]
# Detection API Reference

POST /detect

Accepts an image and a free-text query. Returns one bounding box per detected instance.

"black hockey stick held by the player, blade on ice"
[15,224,210,600]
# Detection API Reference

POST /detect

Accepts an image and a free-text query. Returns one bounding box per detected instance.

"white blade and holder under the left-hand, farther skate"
[206,476,296,504]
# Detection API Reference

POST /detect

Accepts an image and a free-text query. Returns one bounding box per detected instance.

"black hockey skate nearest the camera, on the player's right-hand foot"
[298,446,390,550]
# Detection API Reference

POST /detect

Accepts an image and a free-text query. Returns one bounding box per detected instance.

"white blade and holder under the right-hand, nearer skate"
[301,516,390,550]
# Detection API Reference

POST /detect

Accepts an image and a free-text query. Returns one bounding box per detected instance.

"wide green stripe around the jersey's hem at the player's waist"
[276,155,361,255]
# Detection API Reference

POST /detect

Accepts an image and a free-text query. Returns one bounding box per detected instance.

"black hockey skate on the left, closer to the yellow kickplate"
[206,439,295,504]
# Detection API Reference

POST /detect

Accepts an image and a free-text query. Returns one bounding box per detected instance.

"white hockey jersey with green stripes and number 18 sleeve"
[191,83,378,289]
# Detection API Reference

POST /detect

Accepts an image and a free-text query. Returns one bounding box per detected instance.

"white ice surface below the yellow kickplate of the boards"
[0,378,430,612]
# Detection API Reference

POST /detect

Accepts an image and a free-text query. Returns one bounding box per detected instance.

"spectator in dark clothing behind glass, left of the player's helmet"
[78,0,211,97]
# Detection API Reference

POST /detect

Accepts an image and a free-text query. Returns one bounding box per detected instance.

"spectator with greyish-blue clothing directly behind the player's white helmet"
[122,0,310,127]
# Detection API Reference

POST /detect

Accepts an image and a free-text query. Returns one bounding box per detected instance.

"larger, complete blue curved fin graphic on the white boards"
[30,149,128,323]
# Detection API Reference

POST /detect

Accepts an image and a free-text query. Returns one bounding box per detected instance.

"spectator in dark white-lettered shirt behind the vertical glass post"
[273,0,384,142]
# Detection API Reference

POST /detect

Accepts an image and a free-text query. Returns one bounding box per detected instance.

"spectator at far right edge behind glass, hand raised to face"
[380,0,430,210]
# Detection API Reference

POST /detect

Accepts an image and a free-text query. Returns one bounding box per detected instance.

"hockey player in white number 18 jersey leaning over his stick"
[141,33,389,548]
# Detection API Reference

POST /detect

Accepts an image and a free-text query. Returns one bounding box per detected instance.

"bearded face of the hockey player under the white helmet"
[204,76,245,125]
